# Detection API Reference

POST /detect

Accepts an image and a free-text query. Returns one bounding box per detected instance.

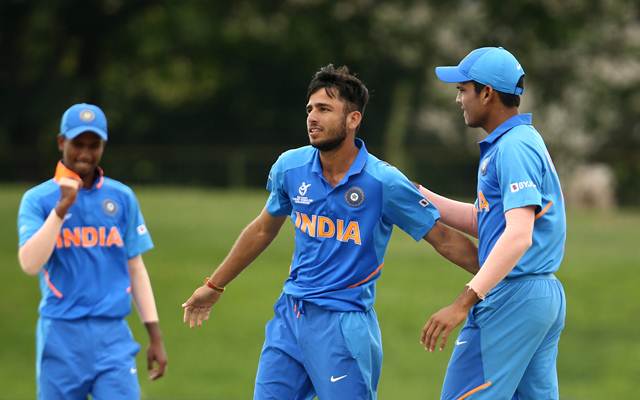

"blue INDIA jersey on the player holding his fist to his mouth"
[18,162,153,319]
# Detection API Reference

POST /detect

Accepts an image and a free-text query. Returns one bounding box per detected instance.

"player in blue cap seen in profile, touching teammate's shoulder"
[421,47,566,400]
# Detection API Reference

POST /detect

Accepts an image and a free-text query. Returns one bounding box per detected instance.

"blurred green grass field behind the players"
[0,186,640,400]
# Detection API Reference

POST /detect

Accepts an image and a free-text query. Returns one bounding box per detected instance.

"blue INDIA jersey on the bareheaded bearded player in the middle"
[266,139,439,311]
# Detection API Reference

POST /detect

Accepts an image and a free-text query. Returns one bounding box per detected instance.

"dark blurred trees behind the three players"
[0,0,640,204]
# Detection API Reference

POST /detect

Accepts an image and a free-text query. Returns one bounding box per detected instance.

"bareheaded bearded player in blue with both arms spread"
[183,65,478,400]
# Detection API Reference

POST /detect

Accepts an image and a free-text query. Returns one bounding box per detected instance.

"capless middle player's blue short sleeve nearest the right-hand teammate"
[382,167,440,241]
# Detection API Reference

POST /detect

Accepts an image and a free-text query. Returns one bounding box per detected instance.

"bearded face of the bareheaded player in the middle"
[307,88,347,151]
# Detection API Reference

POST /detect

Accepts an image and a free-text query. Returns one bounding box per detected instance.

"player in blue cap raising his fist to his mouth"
[18,104,167,400]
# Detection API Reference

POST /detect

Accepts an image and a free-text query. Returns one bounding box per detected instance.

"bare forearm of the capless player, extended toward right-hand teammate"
[424,222,480,274]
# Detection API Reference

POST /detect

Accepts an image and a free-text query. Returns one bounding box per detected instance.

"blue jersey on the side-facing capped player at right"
[476,114,566,278]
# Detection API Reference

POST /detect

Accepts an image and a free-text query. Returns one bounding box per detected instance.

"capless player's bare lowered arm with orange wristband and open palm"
[182,209,286,328]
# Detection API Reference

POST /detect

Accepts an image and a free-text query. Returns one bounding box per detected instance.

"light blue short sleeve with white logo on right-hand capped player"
[496,141,544,212]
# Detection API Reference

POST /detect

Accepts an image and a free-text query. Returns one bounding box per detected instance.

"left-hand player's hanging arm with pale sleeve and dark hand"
[129,255,167,380]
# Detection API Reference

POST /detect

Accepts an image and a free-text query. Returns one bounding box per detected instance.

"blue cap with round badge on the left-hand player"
[60,103,107,140]
